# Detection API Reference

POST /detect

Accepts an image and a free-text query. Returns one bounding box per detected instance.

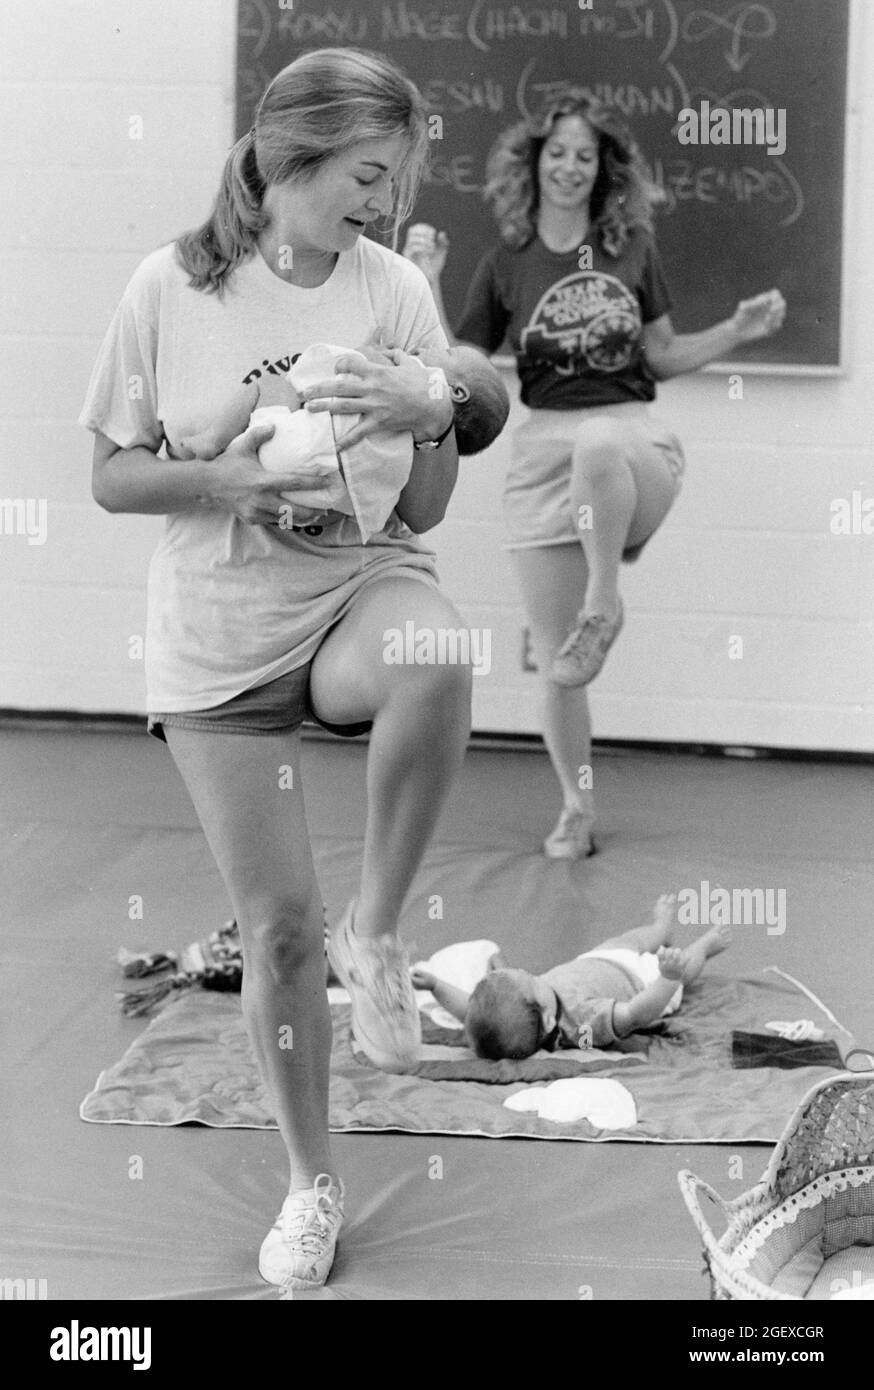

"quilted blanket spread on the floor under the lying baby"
[79,970,852,1144]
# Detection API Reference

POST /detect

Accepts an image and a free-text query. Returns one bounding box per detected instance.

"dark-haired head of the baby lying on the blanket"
[464,970,556,1062]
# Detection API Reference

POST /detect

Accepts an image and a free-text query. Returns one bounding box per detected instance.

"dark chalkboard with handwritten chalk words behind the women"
[238,0,849,370]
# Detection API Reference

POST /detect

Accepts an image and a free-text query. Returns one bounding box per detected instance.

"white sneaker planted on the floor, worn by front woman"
[258,1173,346,1290]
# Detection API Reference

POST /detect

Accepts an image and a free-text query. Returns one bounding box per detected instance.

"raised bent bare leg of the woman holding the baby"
[310,577,471,938]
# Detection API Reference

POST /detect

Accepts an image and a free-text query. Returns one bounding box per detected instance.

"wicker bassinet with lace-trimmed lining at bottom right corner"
[678,1058,874,1301]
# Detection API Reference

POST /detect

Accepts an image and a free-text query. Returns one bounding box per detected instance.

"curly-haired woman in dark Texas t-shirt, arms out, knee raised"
[404,92,785,859]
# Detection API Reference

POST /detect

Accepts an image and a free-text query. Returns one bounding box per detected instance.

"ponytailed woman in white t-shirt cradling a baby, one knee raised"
[81,49,502,1289]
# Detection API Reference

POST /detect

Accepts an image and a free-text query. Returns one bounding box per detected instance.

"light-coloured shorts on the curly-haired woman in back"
[503,400,685,560]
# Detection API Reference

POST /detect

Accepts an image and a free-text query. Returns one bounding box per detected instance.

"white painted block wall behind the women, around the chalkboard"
[0,0,874,749]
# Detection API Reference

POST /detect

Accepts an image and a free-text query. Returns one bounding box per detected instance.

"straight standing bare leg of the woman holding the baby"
[164,726,336,1191]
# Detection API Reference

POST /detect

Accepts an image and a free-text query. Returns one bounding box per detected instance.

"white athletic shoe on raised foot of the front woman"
[328,902,422,1072]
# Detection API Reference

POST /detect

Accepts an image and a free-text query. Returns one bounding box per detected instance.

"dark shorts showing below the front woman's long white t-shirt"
[146,662,372,742]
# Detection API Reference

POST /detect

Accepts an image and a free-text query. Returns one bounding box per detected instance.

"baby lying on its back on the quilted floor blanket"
[413,895,731,1061]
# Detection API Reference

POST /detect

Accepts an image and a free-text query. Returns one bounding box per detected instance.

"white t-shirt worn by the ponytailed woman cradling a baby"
[79,236,446,713]
